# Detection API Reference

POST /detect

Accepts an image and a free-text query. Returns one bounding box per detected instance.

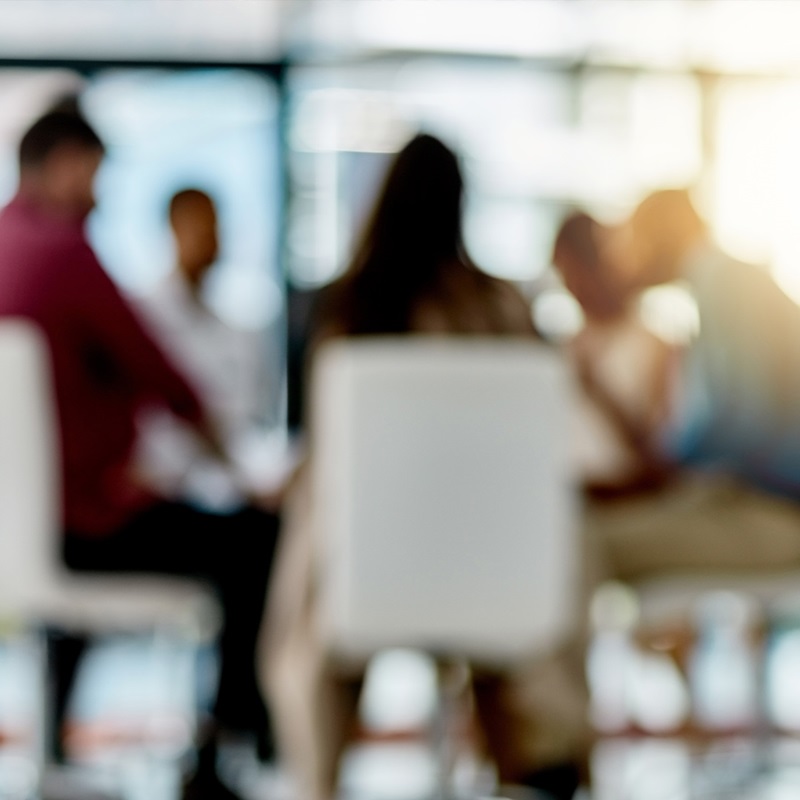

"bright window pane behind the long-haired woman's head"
[288,59,572,286]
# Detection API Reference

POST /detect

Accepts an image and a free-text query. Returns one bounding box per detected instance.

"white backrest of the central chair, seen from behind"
[310,336,579,663]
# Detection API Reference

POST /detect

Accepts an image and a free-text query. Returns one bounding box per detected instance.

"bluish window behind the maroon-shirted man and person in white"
[0,69,285,424]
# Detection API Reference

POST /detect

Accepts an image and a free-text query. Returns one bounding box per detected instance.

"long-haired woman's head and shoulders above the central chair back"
[315,134,533,343]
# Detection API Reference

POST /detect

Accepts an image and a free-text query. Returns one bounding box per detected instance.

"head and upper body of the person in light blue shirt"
[628,189,800,499]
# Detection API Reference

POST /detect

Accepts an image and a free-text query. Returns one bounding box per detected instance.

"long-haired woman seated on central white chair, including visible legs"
[263,135,582,800]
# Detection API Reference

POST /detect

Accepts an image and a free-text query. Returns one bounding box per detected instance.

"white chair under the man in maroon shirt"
[0,319,220,796]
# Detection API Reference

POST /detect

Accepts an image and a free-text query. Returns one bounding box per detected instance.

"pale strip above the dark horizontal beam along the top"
[0,0,800,74]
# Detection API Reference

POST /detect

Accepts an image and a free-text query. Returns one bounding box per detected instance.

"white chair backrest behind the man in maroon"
[0,318,60,614]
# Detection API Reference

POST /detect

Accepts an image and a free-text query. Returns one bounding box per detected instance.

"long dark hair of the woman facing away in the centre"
[320,134,473,334]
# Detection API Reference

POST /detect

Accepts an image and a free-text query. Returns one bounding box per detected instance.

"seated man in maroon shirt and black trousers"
[0,103,278,798]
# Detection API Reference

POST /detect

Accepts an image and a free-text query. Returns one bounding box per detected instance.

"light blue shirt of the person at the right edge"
[667,245,800,497]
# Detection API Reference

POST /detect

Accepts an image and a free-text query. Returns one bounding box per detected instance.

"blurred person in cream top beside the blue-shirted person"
[552,211,677,497]
